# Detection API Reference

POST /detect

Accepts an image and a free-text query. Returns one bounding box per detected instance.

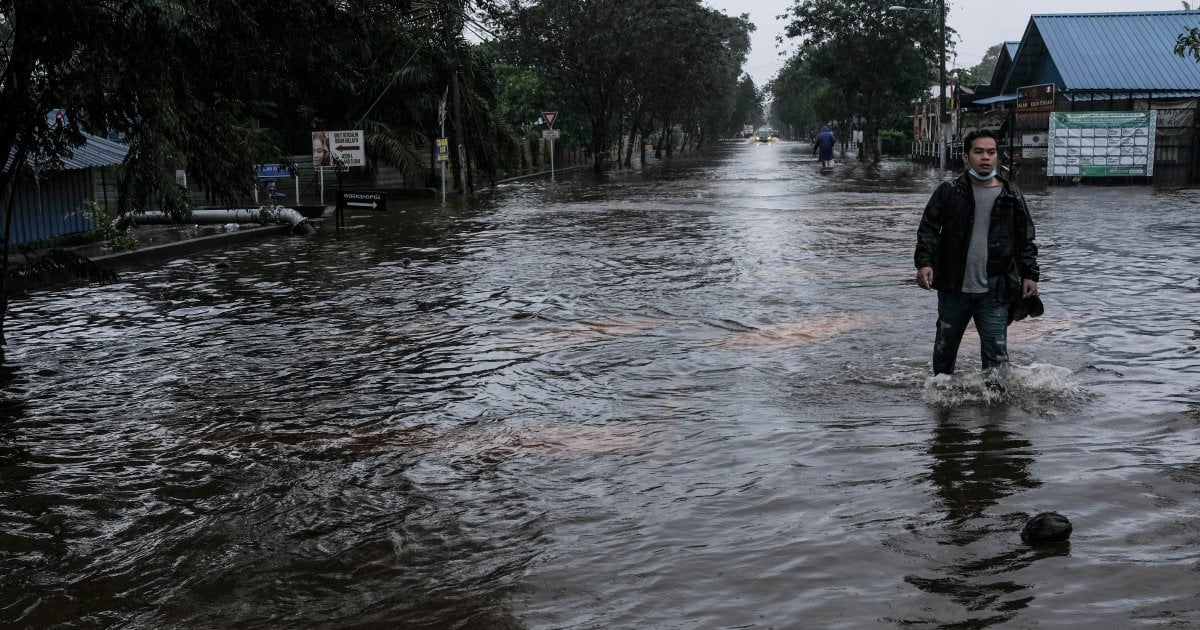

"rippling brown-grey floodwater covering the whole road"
[0,142,1200,629]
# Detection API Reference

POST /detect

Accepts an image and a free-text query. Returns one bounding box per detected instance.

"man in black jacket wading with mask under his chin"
[913,130,1039,392]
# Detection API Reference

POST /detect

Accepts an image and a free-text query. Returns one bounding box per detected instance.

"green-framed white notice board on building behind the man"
[1046,109,1157,178]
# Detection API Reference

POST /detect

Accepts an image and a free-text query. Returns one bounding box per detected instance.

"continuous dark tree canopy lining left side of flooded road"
[0,0,754,205]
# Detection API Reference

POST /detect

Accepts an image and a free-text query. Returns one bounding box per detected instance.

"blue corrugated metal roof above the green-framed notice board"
[1003,11,1200,96]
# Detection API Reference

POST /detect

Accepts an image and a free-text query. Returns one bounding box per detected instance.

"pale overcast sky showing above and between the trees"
[704,0,1200,86]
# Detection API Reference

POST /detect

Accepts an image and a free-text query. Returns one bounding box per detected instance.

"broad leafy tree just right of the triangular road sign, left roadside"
[504,0,752,170]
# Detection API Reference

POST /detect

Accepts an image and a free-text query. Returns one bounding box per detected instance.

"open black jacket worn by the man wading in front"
[913,173,1039,302]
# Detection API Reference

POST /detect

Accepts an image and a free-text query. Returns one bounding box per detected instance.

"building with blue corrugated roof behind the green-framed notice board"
[960,11,1200,185]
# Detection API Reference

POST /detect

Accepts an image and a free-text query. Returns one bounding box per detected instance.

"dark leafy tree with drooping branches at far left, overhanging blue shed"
[0,0,285,343]
